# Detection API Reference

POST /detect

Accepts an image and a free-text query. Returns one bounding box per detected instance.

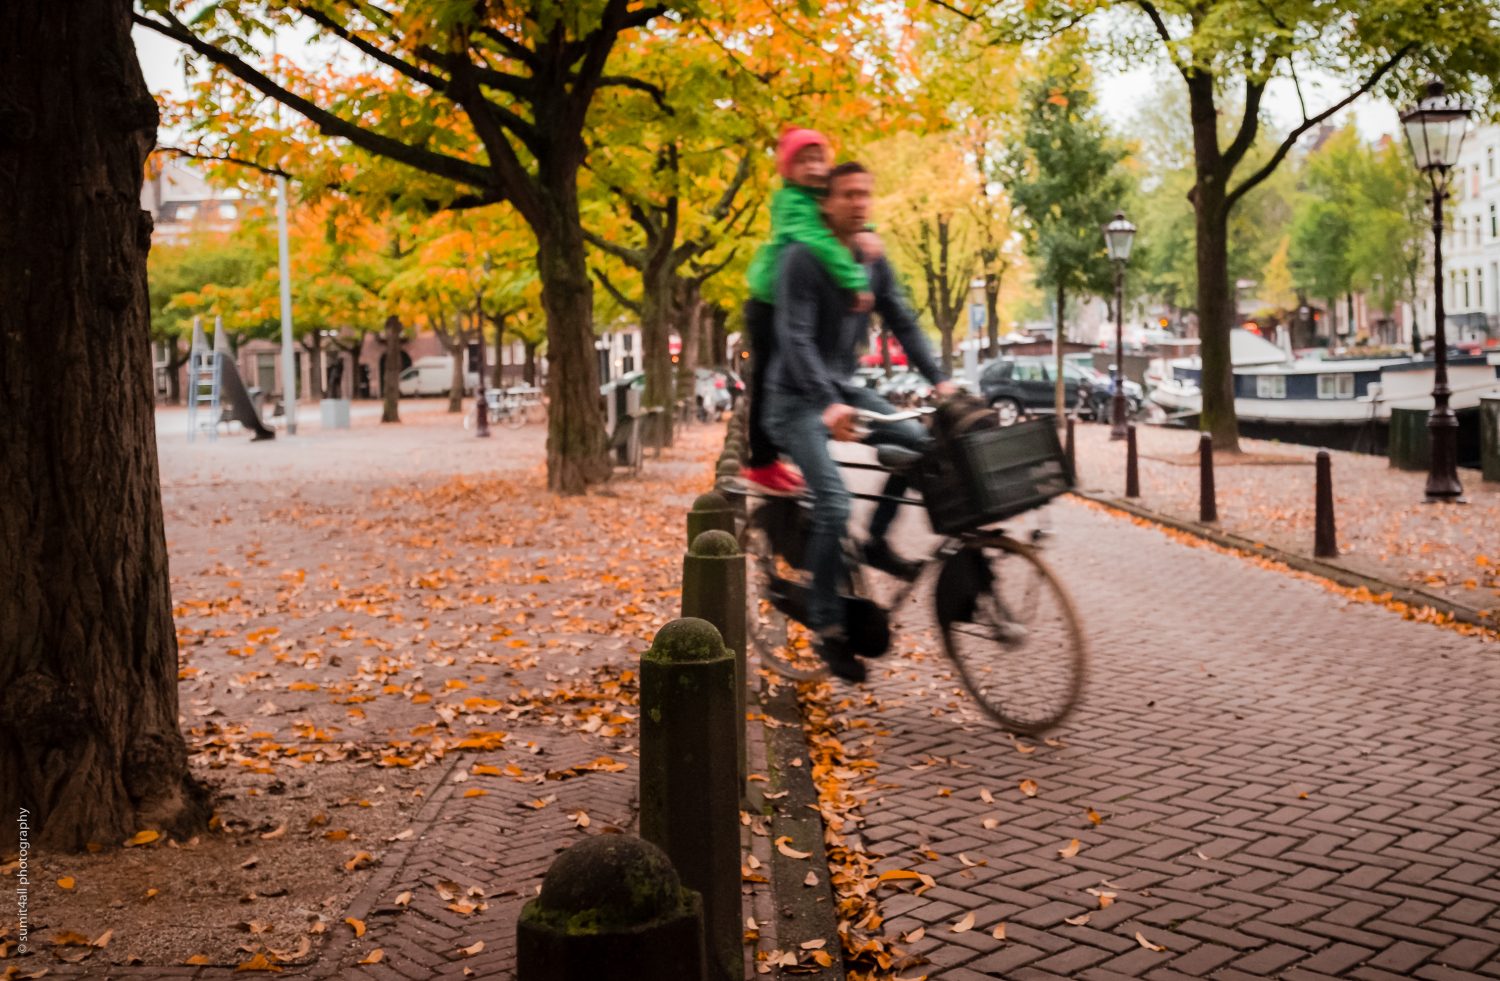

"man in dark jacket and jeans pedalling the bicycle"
[765,162,957,681]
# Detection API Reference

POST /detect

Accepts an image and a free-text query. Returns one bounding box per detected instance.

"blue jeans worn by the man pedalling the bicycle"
[765,386,932,630]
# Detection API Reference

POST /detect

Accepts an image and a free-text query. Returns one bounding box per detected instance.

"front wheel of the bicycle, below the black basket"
[935,534,1088,735]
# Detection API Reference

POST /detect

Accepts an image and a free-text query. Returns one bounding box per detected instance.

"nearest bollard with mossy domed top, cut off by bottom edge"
[516,834,708,981]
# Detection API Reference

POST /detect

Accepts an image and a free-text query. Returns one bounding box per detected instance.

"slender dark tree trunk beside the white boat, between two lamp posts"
[1188,75,1239,453]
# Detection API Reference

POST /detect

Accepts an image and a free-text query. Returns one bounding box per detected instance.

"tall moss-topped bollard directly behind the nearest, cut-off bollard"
[641,618,744,981]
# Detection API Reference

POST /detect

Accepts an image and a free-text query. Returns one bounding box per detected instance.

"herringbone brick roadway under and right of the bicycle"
[839,501,1500,981]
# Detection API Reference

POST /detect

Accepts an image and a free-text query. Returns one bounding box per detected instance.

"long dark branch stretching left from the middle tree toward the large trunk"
[131,12,503,193]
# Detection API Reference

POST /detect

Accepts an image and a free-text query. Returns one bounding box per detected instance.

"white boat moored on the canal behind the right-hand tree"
[1148,329,1500,426]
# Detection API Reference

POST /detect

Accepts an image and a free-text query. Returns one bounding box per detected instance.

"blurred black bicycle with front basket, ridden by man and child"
[740,408,1088,735]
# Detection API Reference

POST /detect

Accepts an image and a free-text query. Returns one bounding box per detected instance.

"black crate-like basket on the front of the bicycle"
[915,419,1074,536]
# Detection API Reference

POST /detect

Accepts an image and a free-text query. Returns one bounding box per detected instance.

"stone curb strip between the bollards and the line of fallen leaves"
[756,683,845,981]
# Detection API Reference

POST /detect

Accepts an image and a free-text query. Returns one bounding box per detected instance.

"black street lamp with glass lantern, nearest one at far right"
[1401,80,1472,503]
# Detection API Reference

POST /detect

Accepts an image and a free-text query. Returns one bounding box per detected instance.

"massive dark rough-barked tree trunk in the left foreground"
[0,0,209,849]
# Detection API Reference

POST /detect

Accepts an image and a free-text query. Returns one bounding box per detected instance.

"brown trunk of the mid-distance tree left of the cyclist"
[536,204,609,494]
